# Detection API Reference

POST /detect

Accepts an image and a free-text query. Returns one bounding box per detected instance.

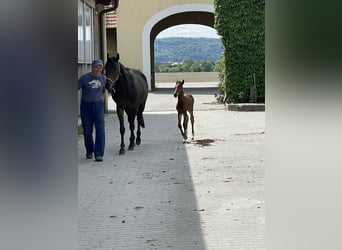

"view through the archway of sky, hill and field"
[152,24,223,89]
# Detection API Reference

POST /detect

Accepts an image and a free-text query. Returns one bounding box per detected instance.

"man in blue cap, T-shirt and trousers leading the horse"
[78,59,106,161]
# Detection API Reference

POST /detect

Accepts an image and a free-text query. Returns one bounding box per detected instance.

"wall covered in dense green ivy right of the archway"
[214,0,265,103]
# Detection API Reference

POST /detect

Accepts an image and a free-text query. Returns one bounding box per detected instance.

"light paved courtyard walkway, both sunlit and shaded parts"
[78,88,265,250]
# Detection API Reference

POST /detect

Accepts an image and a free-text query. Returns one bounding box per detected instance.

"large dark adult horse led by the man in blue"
[105,54,148,154]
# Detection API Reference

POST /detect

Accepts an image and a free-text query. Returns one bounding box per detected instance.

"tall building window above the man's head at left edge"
[78,0,94,63]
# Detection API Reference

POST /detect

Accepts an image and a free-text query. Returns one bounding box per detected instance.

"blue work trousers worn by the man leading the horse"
[80,100,105,157]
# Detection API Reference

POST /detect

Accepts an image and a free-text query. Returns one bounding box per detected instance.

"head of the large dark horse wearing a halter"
[104,54,120,92]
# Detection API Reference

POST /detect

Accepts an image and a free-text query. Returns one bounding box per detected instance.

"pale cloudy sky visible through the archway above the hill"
[157,24,219,38]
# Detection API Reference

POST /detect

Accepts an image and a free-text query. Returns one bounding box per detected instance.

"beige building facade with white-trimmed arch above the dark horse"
[116,0,214,90]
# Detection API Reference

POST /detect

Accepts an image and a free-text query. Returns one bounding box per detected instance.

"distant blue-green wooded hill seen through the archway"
[154,37,223,63]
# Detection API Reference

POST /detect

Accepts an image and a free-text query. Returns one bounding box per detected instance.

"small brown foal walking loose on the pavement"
[173,80,195,141]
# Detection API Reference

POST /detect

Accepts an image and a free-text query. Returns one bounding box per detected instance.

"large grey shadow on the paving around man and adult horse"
[78,113,206,249]
